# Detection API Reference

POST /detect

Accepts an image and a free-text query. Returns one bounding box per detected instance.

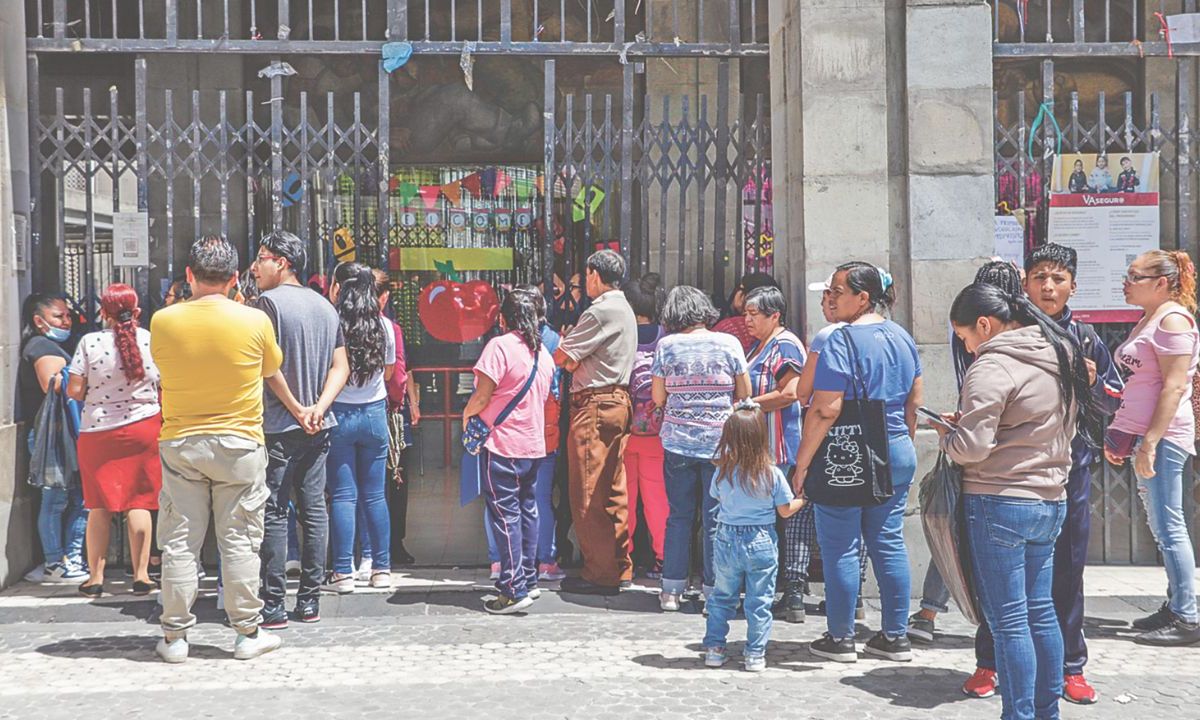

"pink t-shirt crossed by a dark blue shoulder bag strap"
[475,332,554,457]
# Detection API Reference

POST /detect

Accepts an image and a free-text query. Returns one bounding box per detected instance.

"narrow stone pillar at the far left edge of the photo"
[0,0,37,588]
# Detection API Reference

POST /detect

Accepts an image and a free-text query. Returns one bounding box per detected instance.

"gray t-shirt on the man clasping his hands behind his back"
[258,284,344,434]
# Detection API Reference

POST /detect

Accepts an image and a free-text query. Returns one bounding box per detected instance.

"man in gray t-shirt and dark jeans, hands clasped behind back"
[252,230,350,629]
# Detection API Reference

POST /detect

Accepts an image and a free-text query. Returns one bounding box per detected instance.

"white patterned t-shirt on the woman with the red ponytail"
[70,328,160,432]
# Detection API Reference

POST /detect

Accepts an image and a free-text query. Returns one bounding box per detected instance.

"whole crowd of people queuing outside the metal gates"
[19,232,1200,718]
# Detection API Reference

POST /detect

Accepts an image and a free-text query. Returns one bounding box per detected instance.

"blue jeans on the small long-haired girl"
[704,523,779,658]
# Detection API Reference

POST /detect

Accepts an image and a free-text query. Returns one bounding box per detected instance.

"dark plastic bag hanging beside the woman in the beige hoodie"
[918,452,983,625]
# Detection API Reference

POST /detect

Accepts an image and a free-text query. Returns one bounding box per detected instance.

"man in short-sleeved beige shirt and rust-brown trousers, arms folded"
[554,250,637,594]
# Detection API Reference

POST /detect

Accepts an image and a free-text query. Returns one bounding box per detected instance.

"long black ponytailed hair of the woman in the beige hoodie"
[950,282,1103,446]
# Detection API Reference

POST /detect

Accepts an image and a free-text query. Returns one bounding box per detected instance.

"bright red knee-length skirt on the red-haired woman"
[79,415,162,512]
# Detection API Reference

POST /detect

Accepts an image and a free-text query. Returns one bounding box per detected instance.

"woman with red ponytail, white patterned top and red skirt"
[67,283,162,598]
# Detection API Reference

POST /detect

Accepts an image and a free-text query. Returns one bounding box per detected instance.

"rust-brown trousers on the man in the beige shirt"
[566,386,634,587]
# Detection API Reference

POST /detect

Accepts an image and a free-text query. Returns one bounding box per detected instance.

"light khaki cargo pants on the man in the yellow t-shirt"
[158,434,270,640]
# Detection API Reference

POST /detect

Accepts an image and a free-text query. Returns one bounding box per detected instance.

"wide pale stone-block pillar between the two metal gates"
[769,0,994,595]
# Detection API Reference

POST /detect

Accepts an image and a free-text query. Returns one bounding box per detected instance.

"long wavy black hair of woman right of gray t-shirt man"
[334,263,388,388]
